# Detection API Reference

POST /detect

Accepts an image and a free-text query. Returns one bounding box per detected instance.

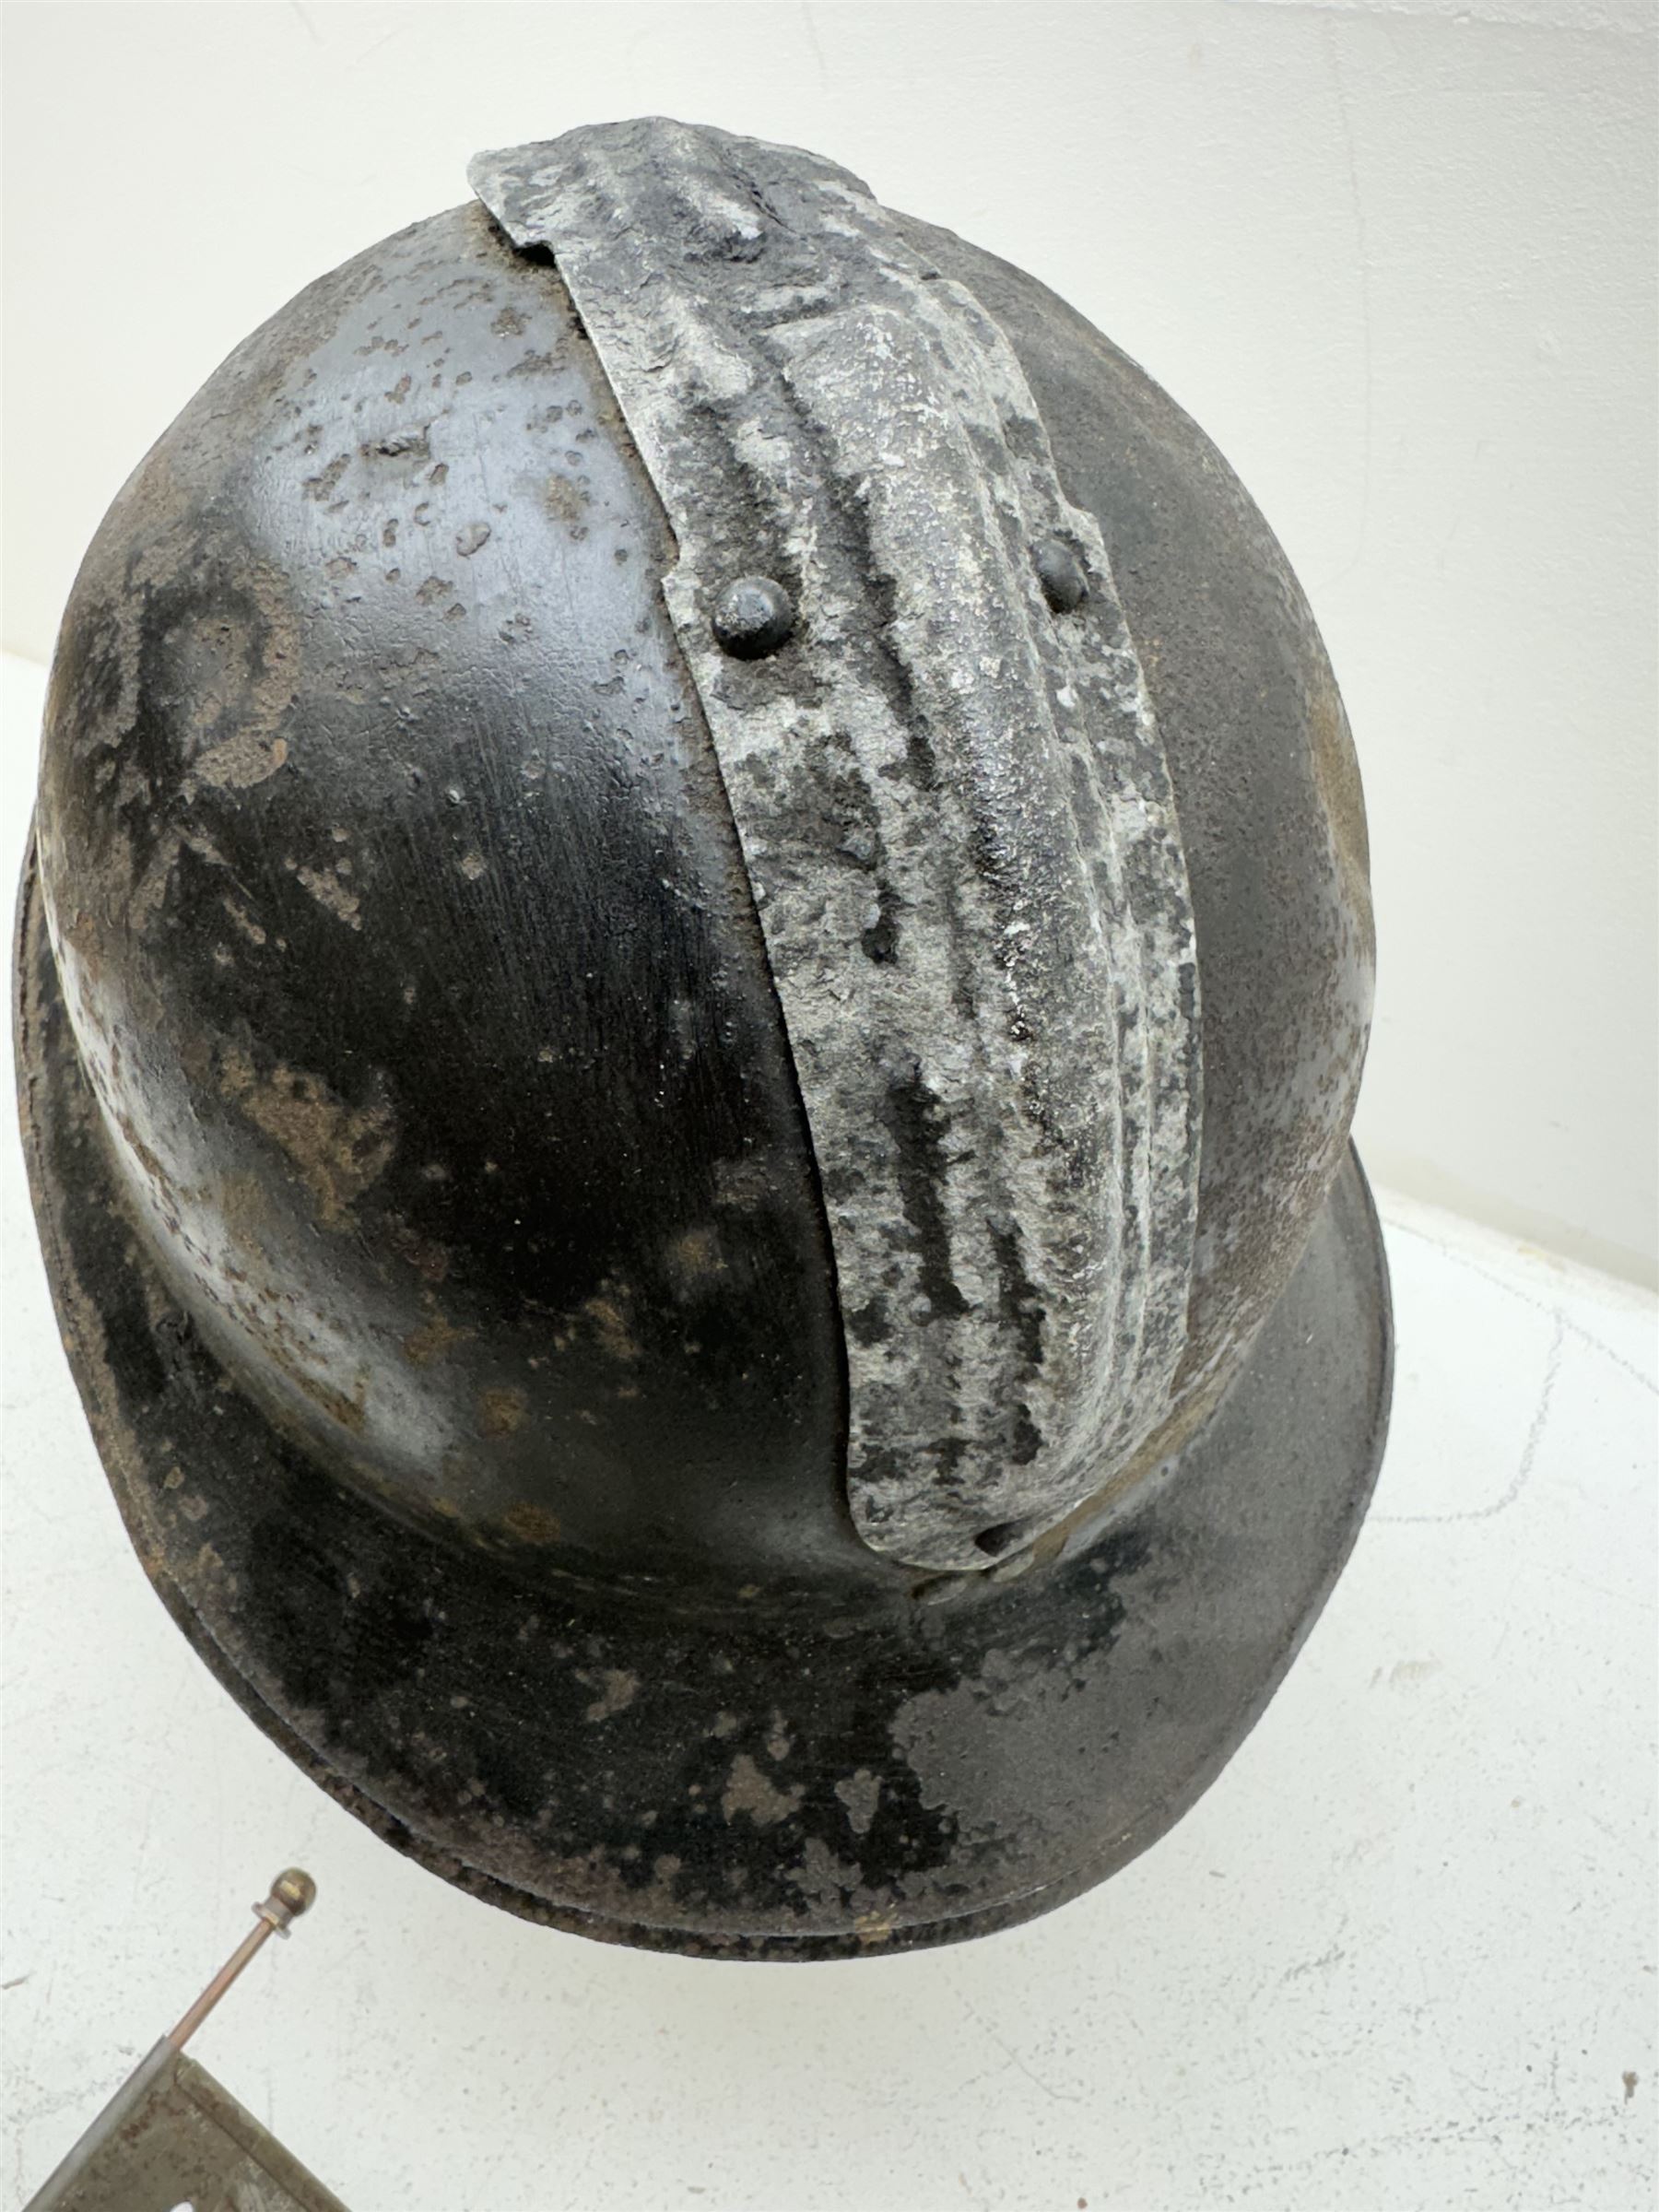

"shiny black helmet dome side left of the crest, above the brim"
[40,208,863,1582]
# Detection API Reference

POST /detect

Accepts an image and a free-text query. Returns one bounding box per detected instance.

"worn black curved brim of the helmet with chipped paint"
[18,844,1392,1959]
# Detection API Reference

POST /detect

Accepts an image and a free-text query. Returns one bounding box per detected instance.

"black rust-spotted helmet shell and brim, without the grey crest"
[18,121,1389,1958]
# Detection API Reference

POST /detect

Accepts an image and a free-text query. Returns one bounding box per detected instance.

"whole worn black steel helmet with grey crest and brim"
[18,122,1389,1958]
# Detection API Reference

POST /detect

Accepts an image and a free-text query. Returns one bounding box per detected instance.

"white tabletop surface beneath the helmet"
[0,664,1659,2212]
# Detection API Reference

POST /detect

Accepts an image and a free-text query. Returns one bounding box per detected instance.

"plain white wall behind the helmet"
[5,0,1659,1278]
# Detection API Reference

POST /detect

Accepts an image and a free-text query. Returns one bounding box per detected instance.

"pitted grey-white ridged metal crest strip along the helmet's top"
[469,122,1201,1569]
